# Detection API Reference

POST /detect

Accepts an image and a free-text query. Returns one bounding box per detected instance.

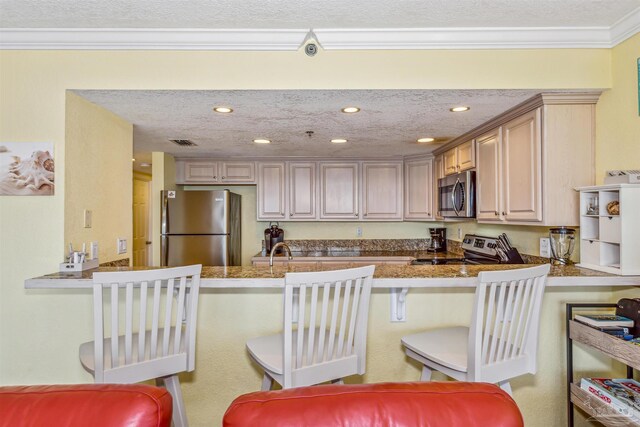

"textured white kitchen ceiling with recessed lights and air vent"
[74,90,540,161]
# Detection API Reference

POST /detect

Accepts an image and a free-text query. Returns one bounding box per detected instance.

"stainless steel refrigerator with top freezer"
[160,190,241,267]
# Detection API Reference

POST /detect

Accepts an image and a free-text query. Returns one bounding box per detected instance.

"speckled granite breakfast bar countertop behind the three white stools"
[25,263,640,289]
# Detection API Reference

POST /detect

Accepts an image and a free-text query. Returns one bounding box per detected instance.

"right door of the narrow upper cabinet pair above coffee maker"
[289,162,317,220]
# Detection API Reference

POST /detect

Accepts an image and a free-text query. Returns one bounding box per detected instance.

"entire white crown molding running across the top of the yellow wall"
[0,11,640,51]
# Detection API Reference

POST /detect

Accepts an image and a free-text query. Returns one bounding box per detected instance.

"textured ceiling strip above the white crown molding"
[0,0,640,29]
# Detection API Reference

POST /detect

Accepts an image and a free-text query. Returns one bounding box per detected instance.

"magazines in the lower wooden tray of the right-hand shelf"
[580,378,640,422]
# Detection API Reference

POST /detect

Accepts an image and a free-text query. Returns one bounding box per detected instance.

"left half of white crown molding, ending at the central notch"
[0,28,309,51]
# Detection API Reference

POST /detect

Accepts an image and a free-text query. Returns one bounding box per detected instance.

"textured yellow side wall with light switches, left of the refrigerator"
[64,92,133,262]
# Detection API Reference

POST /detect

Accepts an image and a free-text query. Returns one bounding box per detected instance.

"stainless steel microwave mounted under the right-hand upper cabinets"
[438,171,476,218]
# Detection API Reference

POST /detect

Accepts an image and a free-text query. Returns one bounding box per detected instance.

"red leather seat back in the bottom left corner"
[0,384,172,427]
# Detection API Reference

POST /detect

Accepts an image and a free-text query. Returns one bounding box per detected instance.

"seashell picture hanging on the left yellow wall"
[0,142,55,196]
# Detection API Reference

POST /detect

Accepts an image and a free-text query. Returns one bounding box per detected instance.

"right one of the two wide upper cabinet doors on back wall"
[362,162,402,220]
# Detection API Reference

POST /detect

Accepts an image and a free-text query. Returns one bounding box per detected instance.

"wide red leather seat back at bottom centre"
[223,381,524,427]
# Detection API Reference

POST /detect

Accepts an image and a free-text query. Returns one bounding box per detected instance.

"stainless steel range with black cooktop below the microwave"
[412,233,524,265]
